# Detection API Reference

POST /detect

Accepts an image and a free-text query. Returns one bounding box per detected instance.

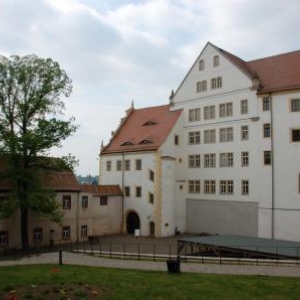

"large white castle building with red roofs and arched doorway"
[99,43,300,241]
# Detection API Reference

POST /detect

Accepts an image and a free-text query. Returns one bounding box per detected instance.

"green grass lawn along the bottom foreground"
[0,265,300,300]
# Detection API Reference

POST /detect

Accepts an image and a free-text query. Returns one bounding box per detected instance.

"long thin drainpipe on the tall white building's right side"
[269,93,275,239]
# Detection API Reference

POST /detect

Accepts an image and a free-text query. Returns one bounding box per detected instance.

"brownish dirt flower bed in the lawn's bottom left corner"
[0,284,109,300]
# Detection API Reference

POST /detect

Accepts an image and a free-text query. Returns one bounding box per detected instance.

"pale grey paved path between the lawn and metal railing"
[0,252,300,277]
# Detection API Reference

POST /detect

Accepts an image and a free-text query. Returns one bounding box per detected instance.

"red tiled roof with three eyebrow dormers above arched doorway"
[101,105,182,154]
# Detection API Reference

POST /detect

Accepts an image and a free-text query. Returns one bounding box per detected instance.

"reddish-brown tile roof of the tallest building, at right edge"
[218,44,300,94]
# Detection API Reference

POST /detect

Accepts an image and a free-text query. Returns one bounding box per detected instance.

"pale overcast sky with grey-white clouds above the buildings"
[0,0,300,175]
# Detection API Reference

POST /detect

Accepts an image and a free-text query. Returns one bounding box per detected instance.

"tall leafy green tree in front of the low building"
[0,55,77,249]
